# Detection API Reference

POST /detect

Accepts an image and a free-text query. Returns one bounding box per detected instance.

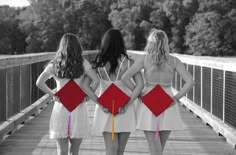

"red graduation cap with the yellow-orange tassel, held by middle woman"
[97,83,130,115]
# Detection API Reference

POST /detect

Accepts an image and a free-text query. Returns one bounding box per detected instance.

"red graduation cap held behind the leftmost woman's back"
[55,80,87,112]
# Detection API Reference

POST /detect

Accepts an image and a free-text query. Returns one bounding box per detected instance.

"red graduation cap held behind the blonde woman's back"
[141,85,174,117]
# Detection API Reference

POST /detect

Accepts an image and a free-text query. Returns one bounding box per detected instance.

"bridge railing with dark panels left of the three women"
[0,53,55,141]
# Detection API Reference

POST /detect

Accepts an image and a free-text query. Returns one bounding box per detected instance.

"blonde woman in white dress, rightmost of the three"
[122,29,194,155]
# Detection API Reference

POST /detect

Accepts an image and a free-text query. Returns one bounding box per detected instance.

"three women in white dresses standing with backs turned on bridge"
[37,29,193,155]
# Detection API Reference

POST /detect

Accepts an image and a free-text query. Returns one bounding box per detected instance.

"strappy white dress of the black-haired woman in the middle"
[92,58,136,135]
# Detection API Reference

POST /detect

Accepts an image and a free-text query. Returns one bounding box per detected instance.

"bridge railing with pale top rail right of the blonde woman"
[172,54,236,146]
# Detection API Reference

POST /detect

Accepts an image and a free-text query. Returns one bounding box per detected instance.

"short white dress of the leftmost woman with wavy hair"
[44,59,91,139]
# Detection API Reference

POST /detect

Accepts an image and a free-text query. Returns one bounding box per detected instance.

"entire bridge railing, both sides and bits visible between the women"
[0,50,236,145]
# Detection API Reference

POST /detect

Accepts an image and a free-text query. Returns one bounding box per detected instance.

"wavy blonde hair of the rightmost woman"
[145,29,169,69]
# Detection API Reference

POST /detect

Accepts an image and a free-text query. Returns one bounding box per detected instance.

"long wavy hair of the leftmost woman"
[51,33,84,79]
